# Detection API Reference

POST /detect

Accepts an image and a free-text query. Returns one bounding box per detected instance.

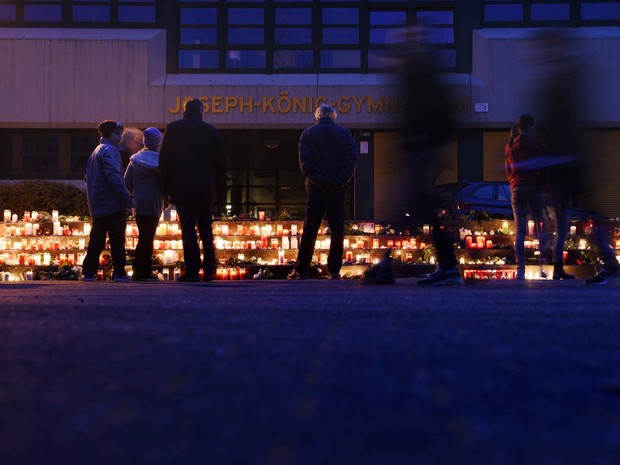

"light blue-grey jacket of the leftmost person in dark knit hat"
[84,137,133,218]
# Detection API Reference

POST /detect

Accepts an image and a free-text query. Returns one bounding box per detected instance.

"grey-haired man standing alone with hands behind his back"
[288,105,357,279]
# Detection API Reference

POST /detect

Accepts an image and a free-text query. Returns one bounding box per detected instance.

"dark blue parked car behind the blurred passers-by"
[434,181,604,220]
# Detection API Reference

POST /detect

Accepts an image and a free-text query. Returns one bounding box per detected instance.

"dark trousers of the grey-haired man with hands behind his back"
[295,184,346,274]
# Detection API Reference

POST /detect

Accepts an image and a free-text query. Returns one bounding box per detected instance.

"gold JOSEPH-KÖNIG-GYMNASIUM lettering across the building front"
[168,90,469,114]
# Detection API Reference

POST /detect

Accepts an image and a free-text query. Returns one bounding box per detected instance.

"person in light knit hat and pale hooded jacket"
[125,128,164,281]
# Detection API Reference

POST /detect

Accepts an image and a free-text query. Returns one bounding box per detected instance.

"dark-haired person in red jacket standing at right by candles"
[504,114,545,279]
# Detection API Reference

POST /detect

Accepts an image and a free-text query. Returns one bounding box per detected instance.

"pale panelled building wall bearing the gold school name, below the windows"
[0,28,620,218]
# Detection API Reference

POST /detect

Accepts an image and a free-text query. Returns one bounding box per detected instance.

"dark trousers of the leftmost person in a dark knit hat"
[82,211,127,276]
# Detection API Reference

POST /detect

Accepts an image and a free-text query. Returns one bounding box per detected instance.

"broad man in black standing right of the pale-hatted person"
[159,99,228,282]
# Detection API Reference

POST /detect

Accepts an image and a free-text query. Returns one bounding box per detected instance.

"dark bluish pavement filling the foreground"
[0,279,620,465]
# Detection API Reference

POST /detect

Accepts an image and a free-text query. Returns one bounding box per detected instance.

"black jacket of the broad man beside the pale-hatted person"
[159,110,228,205]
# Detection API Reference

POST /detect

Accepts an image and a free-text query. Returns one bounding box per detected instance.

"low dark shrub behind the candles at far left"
[0,181,89,218]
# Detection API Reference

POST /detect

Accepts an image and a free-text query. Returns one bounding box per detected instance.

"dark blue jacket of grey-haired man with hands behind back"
[299,117,357,188]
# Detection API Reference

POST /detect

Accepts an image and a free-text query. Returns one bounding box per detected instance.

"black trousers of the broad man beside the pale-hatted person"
[176,202,216,277]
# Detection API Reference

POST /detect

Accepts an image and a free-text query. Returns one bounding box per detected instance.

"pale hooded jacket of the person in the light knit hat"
[125,149,164,218]
